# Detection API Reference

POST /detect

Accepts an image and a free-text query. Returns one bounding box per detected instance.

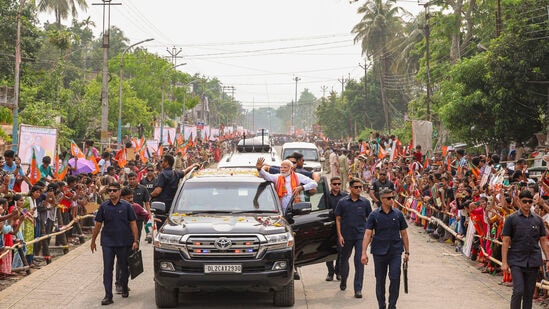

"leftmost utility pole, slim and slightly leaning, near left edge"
[11,0,26,153]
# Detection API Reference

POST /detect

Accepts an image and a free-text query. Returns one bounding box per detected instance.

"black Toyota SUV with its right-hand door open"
[152,168,337,308]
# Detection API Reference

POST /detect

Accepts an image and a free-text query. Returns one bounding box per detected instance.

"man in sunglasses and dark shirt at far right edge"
[501,189,549,309]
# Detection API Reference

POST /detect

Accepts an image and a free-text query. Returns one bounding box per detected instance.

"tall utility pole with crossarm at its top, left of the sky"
[92,0,122,147]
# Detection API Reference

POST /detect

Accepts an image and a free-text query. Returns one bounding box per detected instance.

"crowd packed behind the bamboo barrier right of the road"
[323,134,549,308]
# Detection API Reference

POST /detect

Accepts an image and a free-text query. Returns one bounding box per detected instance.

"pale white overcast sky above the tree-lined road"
[41,0,420,109]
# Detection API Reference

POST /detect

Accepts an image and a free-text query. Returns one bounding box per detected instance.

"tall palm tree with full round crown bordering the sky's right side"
[352,0,406,132]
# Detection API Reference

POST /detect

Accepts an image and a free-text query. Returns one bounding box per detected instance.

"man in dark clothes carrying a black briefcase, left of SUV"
[90,182,139,305]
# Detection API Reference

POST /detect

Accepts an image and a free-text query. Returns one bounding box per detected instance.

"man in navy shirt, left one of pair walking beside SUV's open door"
[334,178,372,298]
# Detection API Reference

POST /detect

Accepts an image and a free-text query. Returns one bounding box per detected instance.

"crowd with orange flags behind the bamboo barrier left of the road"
[0,140,218,292]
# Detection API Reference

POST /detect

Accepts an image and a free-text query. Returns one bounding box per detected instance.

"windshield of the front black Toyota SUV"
[174,182,278,213]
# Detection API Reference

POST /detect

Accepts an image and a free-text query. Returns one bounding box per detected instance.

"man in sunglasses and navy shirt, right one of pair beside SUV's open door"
[362,188,410,309]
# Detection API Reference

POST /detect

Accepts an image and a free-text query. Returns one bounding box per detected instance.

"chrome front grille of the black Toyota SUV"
[186,235,260,259]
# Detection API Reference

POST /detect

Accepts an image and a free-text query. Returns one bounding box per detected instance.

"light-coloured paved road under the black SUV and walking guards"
[0,220,541,309]
